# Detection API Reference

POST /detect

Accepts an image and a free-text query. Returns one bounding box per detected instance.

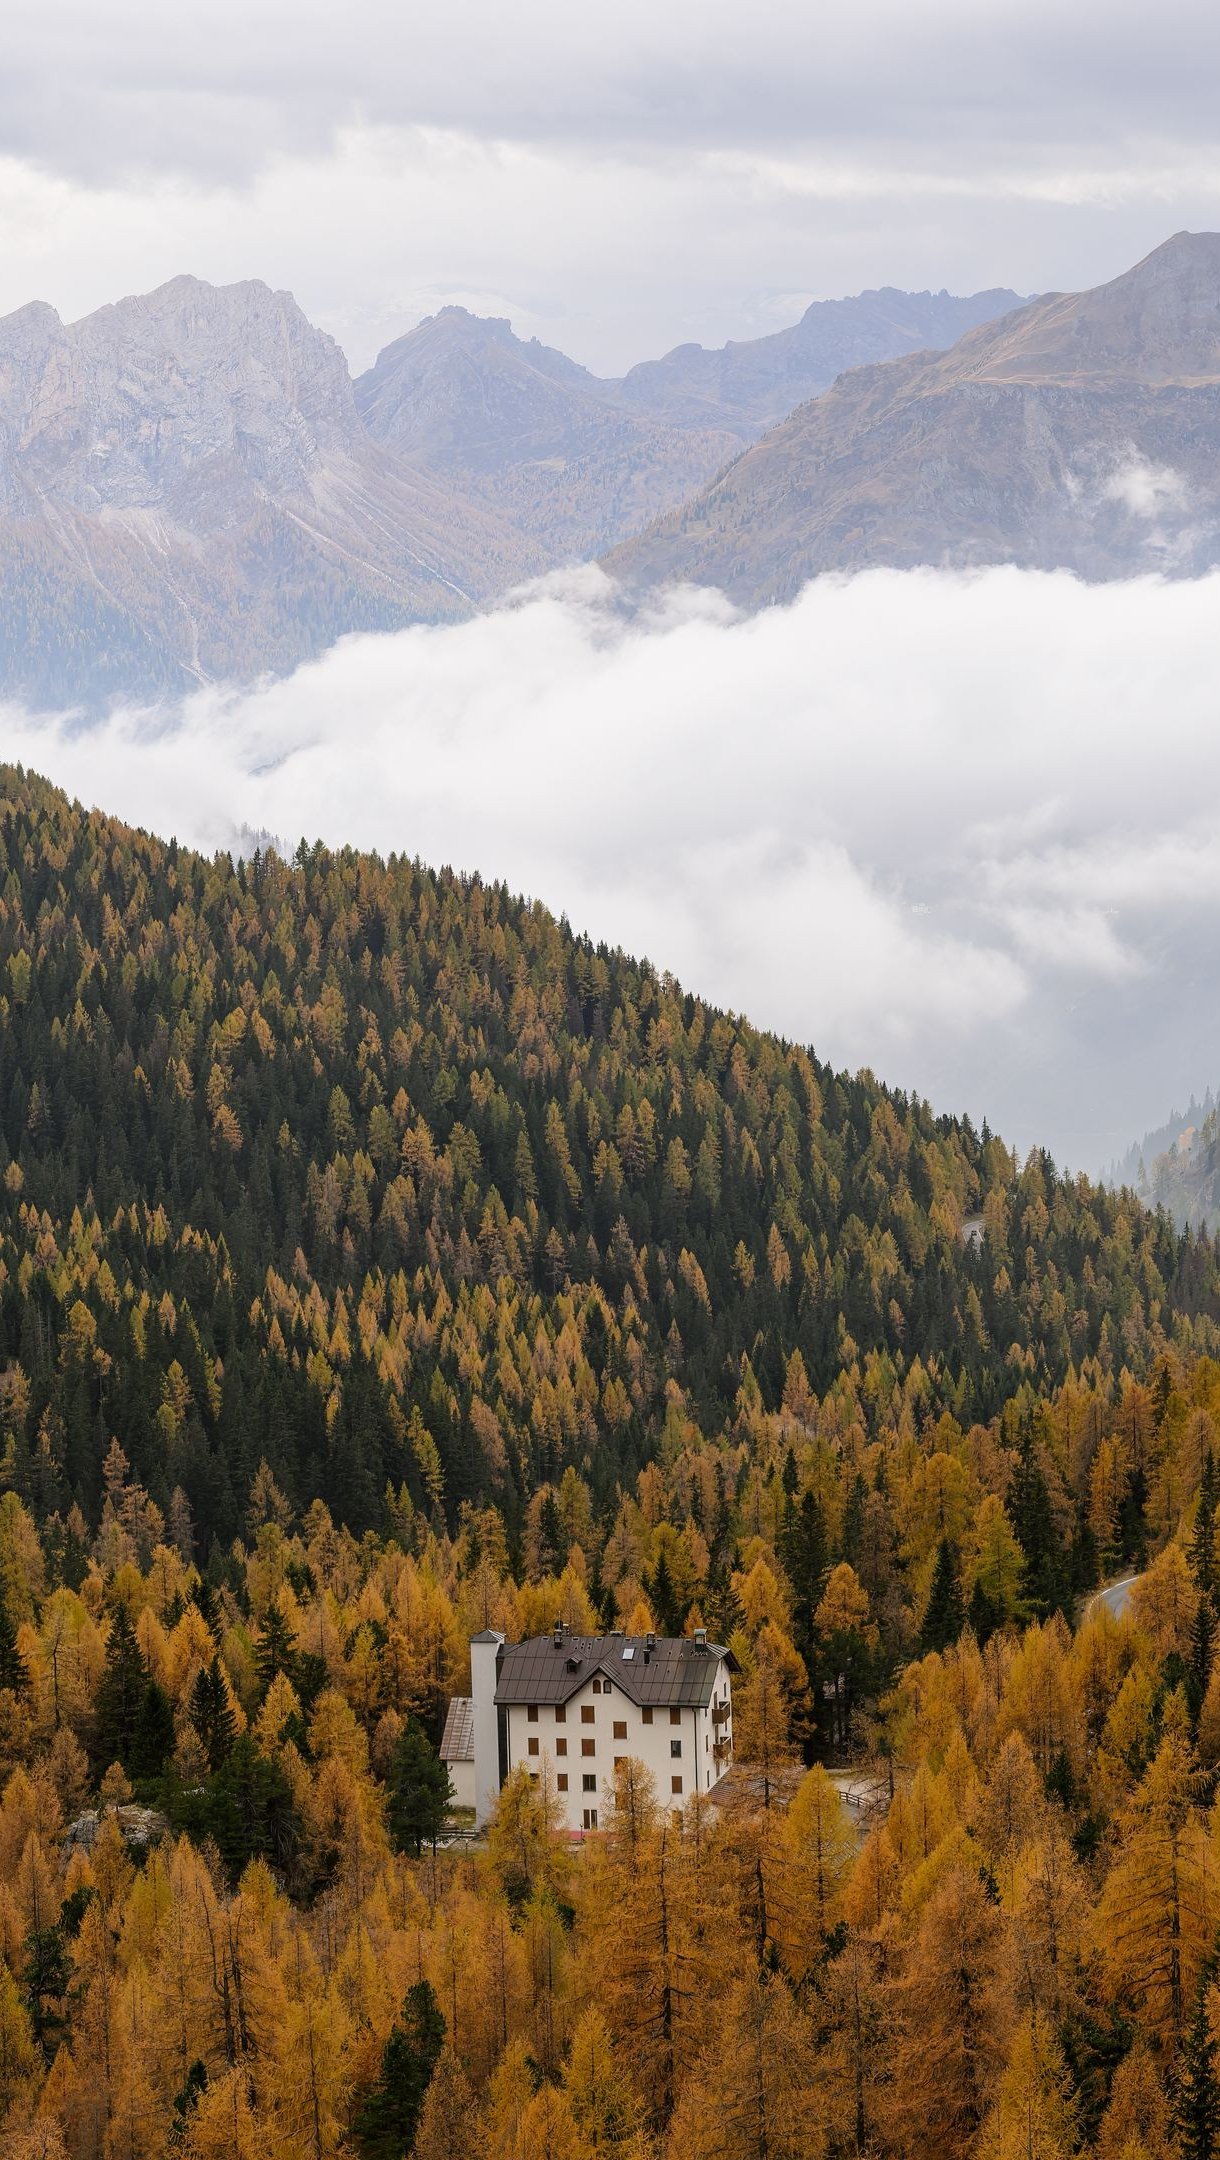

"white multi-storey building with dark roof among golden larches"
[471,1626,736,1832]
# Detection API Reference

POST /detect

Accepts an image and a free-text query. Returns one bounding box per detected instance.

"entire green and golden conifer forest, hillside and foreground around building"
[0,769,1220,2160]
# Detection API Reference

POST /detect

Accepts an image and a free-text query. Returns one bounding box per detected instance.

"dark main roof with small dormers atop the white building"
[497,1635,736,1709]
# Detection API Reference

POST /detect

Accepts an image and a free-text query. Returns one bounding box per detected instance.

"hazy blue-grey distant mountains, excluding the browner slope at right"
[0,276,1015,706]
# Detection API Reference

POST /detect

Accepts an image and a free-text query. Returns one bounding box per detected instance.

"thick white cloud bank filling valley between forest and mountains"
[0,570,1220,1166]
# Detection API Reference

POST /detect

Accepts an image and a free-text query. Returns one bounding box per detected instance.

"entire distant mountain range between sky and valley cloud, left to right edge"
[0,233,1220,708]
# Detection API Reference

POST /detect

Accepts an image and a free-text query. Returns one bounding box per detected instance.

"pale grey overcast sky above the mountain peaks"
[0,0,1220,369]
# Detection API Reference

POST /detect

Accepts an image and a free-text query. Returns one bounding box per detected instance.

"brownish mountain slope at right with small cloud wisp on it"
[609,233,1220,605]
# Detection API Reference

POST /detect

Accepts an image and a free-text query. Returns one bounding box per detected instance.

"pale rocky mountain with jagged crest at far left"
[0,279,540,702]
